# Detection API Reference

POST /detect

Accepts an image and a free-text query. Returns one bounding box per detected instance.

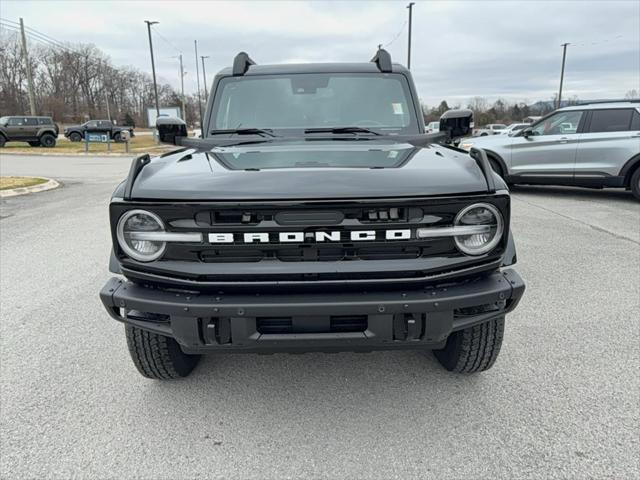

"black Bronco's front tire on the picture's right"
[433,317,504,373]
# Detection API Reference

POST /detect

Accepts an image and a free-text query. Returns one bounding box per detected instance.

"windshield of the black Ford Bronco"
[210,73,418,134]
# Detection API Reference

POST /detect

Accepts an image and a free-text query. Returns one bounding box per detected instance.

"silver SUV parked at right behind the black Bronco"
[460,100,640,200]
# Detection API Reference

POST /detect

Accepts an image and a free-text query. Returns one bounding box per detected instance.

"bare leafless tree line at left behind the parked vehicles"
[0,31,198,126]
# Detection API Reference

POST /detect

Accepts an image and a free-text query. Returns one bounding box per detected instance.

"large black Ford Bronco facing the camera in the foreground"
[100,50,524,379]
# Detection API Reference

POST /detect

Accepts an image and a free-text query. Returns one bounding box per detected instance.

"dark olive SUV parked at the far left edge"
[0,116,59,148]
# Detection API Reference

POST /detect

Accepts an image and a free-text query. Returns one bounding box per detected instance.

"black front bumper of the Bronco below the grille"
[100,269,525,353]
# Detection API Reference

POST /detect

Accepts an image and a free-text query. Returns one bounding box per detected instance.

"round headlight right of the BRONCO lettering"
[454,203,504,255]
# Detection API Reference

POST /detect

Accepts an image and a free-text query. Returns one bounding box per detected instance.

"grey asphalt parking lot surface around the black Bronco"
[0,155,640,479]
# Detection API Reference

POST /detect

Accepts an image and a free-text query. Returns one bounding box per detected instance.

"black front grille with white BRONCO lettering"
[111,196,509,283]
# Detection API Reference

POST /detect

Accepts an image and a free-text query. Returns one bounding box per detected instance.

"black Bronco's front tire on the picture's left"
[125,325,200,380]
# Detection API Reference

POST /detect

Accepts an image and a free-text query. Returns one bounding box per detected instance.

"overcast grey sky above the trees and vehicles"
[0,0,640,105]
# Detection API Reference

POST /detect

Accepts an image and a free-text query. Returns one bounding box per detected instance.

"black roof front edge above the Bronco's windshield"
[218,62,408,76]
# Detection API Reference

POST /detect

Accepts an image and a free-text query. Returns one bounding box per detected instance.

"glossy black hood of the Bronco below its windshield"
[132,140,487,201]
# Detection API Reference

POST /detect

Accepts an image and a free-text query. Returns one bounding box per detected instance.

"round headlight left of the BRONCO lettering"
[117,210,167,262]
